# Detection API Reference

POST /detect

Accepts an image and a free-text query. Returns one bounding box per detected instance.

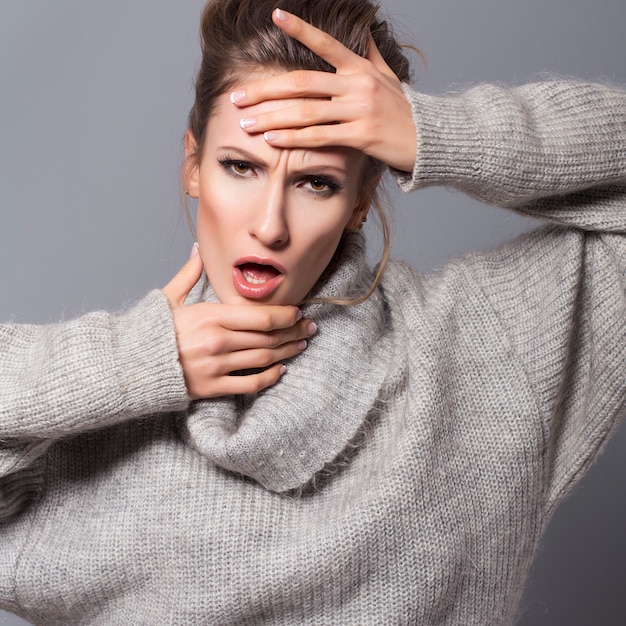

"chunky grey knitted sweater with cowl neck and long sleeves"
[0,82,626,626]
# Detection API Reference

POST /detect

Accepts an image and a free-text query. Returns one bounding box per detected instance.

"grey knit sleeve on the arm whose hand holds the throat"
[0,290,188,518]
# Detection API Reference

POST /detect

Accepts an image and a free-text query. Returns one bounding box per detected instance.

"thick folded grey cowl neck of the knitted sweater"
[178,232,392,492]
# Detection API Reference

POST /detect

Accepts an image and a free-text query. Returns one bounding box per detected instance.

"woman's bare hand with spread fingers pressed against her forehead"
[231,9,416,172]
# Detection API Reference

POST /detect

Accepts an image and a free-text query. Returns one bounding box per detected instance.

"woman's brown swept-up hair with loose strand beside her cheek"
[186,0,410,304]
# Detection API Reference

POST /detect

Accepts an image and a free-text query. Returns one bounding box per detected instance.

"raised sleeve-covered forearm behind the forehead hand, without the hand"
[397,82,626,230]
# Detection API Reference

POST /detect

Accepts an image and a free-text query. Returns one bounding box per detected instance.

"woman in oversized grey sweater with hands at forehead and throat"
[2,2,625,624]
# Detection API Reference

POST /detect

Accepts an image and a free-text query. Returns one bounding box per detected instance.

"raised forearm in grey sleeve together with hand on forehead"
[231,11,626,232]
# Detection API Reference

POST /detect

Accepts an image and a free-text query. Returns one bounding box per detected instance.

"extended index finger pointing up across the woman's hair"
[272,9,363,71]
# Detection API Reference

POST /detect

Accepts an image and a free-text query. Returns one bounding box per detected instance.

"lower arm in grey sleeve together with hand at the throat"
[0,247,314,519]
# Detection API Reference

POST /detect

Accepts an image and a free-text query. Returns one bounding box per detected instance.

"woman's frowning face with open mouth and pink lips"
[186,83,367,304]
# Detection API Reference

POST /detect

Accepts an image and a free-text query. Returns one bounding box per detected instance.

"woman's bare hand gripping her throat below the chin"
[162,245,315,399]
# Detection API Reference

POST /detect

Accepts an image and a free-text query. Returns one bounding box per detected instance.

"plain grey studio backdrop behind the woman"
[0,0,626,626]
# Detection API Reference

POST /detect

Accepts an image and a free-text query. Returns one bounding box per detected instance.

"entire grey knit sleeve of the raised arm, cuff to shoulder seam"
[396,82,626,512]
